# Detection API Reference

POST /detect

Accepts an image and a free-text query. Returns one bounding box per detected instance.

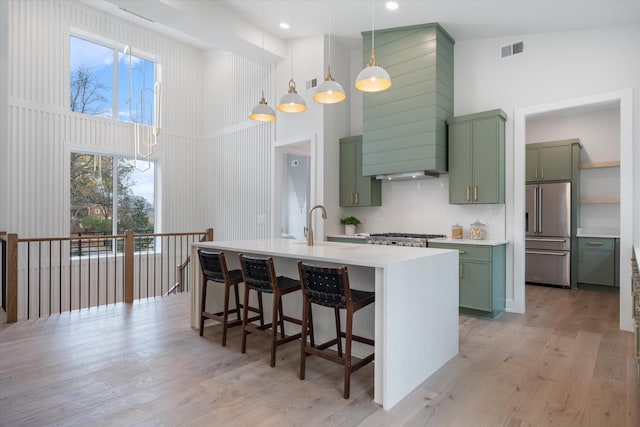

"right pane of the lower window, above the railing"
[118,159,155,234]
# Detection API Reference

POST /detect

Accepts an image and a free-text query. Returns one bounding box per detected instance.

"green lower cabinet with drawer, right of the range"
[429,241,507,319]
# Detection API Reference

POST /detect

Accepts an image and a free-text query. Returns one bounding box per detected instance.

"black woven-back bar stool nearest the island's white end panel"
[298,261,375,399]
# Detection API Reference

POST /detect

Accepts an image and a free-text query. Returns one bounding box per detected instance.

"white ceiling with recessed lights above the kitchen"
[90,0,640,56]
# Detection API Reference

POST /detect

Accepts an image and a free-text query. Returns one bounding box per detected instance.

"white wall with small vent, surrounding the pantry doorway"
[455,26,640,328]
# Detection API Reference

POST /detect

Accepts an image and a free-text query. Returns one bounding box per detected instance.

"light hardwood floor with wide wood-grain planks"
[0,286,640,427]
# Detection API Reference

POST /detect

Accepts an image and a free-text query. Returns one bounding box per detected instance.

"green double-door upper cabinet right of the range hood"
[448,110,507,204]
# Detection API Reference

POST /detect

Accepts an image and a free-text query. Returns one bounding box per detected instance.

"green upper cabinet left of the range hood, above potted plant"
[340,135,382,207]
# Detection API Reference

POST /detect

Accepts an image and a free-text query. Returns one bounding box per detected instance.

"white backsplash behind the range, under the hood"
[338,175,505,239]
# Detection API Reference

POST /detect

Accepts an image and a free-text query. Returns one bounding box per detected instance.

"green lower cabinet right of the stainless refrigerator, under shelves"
[578,237,620,287]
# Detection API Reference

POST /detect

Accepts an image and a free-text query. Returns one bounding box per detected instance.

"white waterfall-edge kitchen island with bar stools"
[191,239,458,410]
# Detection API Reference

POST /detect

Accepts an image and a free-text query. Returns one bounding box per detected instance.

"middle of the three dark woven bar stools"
[240,254,302,367]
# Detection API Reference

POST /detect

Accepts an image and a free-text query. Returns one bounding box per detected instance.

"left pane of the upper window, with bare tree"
[69,36,113,118]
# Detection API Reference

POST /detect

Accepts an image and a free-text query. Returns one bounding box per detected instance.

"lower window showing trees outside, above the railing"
[70,152,155,241]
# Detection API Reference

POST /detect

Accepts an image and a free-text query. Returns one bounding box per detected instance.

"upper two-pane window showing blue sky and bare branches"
[69,36,157,126]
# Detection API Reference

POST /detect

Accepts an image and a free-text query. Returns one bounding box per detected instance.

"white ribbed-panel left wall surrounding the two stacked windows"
[0,0,203,237]
